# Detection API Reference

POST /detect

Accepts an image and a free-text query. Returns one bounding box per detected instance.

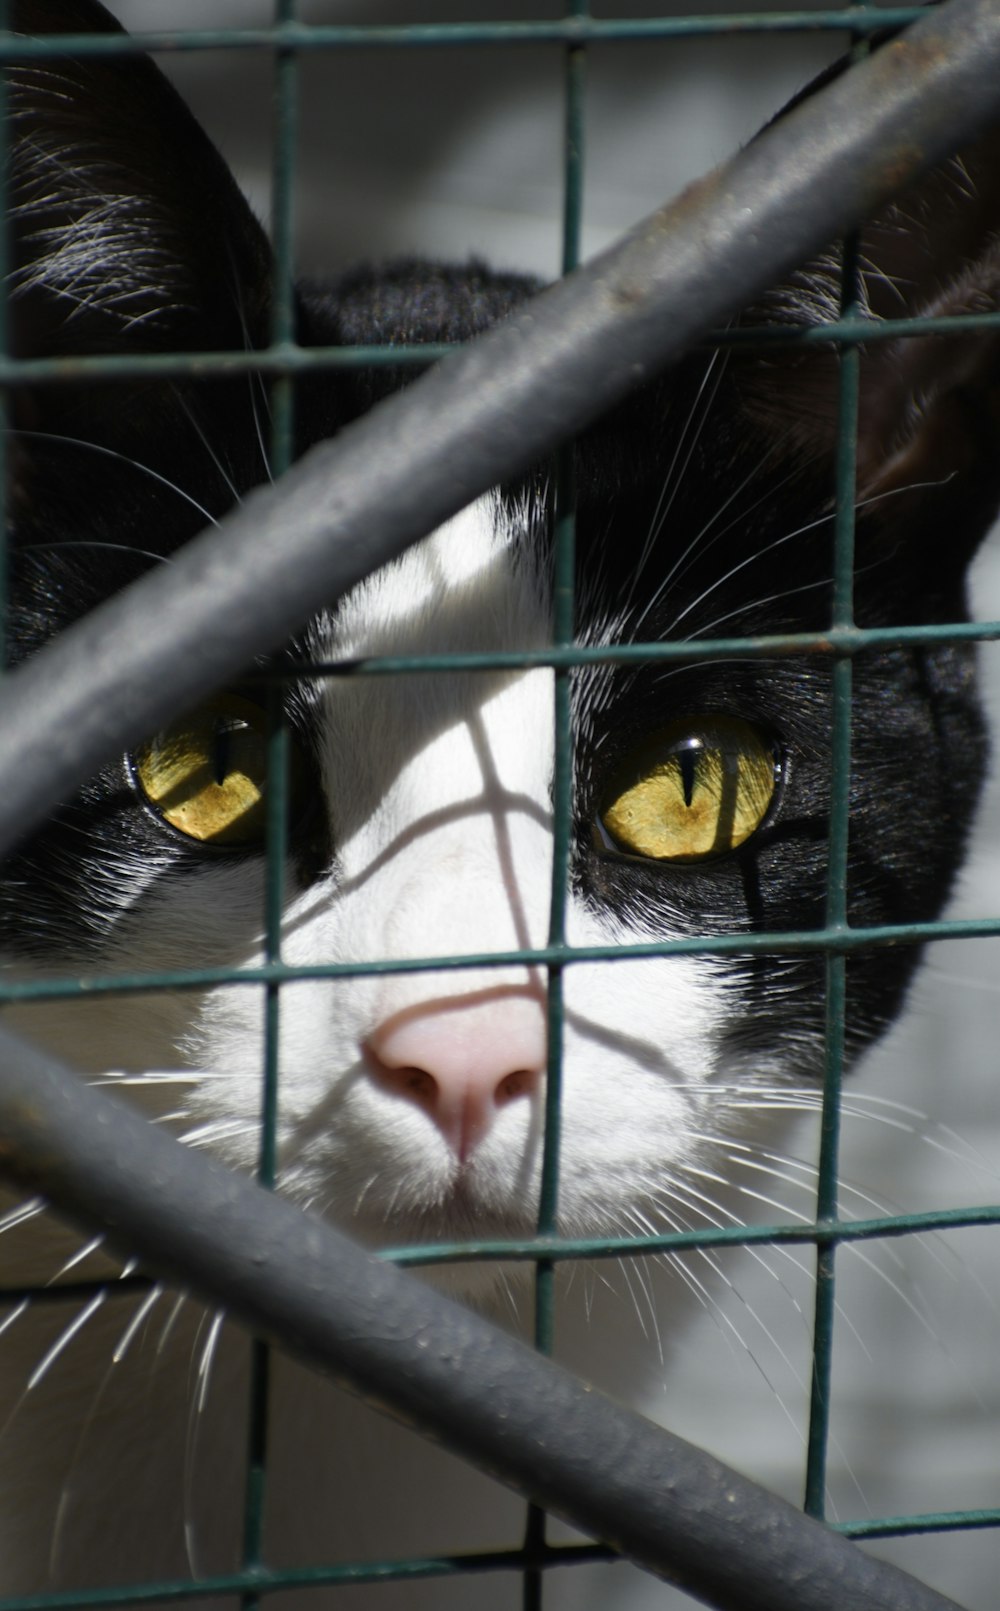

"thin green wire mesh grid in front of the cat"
[0,0,1000,1611]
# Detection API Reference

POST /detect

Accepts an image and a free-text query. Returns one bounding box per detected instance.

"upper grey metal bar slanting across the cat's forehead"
[0,0,1000,851]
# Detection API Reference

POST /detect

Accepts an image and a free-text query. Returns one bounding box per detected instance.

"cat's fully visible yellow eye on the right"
[599,715,778,862]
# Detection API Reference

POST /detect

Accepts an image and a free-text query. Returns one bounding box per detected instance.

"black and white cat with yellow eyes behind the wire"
[0,0,1000,1608]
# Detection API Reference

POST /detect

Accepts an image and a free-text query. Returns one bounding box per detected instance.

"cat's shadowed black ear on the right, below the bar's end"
[731,111,1000,592]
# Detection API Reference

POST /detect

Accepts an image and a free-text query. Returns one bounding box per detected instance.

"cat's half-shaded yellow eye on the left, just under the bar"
[132,694,301,846]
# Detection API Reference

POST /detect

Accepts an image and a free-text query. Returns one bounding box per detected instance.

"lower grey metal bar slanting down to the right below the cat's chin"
[0,1028,972,1611]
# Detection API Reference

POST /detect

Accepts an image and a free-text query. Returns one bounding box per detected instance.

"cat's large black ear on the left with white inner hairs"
[8,0,280,557]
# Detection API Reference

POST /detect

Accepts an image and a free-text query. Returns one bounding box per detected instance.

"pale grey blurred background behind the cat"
[99,0,1000,1611]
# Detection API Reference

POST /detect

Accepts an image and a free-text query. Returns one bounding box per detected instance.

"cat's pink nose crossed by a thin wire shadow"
[366,989,548,1163]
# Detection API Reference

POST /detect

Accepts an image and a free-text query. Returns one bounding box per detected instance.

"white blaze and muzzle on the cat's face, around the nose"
[163,498,721,1263]
